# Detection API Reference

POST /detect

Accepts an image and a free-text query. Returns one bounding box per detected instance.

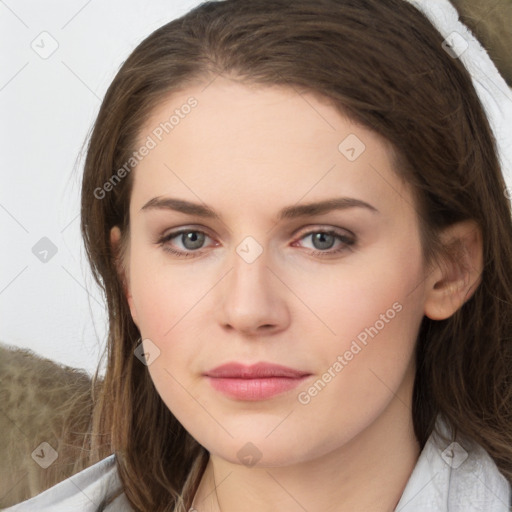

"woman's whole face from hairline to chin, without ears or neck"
[115,77,425,466]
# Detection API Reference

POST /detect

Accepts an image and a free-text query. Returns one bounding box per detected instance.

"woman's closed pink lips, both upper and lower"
[204,363,311,401]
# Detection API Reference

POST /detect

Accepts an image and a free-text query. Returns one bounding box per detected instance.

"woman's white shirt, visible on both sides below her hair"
[4,423,512,512]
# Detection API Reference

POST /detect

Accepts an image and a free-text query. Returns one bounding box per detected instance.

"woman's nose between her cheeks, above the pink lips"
[218,243,289,335]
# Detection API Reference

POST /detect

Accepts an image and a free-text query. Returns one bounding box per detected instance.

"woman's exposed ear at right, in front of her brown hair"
[425,220,483,320]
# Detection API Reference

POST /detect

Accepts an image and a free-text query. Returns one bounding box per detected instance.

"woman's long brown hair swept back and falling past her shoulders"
[81,0,512,512]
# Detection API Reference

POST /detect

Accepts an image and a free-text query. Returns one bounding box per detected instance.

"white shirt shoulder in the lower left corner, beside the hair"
[4,454,131,512]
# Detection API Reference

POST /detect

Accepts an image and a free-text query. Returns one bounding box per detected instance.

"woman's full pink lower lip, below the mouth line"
[208,375,308,401]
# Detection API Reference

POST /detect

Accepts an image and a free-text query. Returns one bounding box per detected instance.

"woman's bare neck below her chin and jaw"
[192,364,420,512]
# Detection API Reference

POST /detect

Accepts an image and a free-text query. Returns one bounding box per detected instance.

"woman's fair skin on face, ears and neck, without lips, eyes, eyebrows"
[111,77,482,512]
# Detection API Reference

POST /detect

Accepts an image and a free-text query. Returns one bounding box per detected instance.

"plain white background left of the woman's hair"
[0,0,206,373]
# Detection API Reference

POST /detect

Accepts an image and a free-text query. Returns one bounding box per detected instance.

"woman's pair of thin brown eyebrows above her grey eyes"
[141,197,379,220]
